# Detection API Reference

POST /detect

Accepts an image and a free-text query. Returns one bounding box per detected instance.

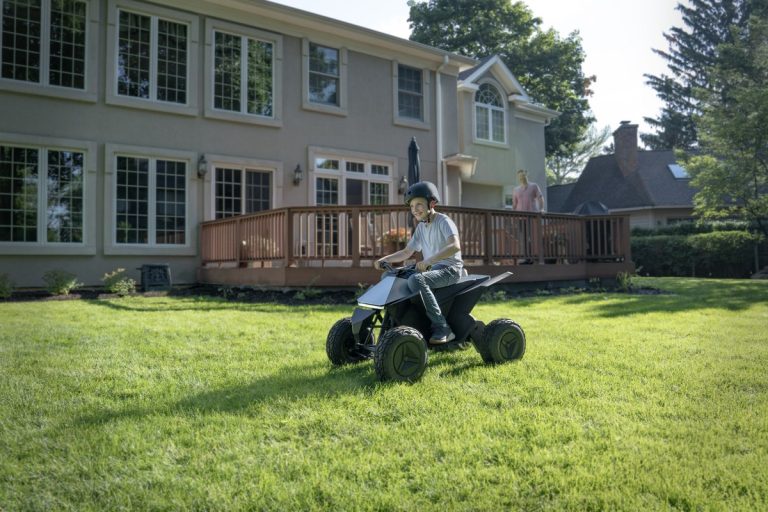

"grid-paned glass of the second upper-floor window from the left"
[117,10,189,104]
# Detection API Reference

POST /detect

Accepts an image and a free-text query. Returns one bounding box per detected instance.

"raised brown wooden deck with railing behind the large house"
[198,205,634,287]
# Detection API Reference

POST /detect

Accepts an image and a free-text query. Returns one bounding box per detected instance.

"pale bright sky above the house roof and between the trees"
[273,0,683,139]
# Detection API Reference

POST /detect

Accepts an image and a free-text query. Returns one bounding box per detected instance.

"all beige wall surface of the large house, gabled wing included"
[0,0,543,287]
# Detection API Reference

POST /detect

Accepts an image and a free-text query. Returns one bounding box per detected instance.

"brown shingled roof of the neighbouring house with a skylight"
[547,150,696,213]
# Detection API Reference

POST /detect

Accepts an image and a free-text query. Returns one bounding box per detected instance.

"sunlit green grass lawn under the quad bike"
[0,278,768,511]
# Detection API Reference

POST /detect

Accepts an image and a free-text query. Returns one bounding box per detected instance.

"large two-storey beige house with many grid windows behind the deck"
[0,0,556,286]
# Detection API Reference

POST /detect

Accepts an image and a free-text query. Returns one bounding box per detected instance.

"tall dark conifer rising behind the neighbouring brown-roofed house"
[640,0,750,150]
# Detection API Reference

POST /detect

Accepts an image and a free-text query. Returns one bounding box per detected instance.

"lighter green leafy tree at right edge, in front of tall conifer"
[686,7,768,236]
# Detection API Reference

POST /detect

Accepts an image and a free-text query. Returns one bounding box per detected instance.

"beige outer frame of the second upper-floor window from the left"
[106,0,200,116]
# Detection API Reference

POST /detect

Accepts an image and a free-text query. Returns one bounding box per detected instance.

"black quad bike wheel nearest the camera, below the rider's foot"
[374,326,427,382]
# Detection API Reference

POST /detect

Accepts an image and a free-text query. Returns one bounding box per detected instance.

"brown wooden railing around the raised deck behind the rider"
[200,205,630,267]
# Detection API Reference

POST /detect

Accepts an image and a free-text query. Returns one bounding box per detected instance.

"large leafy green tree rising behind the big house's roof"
[408,0,595,156]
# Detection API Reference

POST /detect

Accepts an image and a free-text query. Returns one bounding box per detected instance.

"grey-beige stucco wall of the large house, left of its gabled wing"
[0,0,458,287]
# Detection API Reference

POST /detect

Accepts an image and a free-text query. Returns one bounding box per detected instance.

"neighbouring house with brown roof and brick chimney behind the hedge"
[547,121,696,228]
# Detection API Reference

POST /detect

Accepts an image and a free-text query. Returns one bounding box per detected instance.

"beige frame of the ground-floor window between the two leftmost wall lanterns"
[203,153,284,221]
